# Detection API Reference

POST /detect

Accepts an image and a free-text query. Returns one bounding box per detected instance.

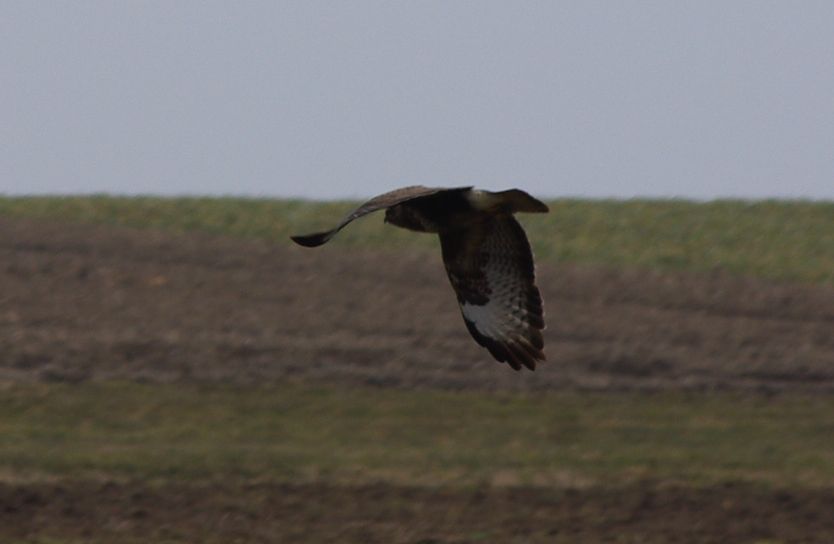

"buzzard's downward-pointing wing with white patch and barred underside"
[440,214,545,370]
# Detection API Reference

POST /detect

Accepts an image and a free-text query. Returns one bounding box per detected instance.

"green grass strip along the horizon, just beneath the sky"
[0,196,834,285]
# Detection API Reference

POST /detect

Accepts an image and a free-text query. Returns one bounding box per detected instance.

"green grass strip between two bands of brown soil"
[0,383,834,487]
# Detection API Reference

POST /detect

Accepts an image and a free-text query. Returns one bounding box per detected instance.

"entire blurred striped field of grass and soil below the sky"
[0,196,834,544]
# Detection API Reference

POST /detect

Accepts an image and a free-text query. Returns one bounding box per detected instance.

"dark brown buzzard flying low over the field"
[292,186,548,370]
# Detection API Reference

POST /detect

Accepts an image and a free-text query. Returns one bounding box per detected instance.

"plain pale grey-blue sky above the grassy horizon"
[0,0,834,199]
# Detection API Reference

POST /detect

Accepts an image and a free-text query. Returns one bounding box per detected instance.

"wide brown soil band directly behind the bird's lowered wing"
[0,215,834,391]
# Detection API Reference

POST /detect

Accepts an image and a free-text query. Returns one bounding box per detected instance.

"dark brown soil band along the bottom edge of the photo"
[6,482,834,544]
